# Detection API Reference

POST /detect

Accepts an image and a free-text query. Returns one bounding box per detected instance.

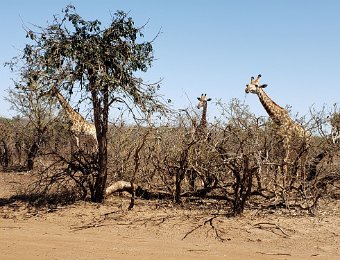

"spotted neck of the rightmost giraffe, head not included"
[257,88,290,125]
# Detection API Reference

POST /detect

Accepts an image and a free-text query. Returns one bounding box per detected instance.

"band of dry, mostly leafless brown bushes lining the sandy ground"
[0,100,340,215]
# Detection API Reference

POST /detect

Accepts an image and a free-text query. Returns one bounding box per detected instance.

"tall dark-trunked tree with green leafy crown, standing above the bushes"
[10,5,164,202]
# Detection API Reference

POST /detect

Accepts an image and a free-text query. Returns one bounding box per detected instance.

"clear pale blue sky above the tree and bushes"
[0,0,340,120]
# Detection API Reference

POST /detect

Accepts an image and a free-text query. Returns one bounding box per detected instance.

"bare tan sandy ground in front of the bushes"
[0,173,340,259]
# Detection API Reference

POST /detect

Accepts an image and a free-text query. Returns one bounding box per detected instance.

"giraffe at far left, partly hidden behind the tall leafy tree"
[51,87,98,150]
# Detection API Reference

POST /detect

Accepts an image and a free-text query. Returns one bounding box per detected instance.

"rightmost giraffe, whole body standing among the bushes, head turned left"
[245,74,310,185]
